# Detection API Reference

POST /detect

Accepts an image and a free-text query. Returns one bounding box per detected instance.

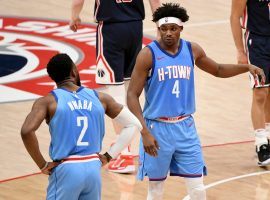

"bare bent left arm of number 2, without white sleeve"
[21,96,57,174]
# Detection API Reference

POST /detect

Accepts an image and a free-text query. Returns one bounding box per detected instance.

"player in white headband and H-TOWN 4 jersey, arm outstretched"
[127,3,265,200]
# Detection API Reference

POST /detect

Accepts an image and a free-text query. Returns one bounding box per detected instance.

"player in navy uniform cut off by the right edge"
[231,0,270,166]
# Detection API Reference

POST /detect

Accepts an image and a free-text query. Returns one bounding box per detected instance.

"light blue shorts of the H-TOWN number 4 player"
[137,116,207,181]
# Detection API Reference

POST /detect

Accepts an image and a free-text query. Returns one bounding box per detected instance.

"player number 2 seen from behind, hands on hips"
[21,54,141,200]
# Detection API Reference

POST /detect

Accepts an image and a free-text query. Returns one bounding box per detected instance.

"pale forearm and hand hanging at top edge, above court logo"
[69,0,84,32]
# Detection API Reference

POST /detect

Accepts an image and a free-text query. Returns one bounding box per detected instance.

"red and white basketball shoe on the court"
[108,154,135,174]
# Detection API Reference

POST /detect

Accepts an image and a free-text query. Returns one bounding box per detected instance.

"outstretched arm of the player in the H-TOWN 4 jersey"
[191,43,265,84]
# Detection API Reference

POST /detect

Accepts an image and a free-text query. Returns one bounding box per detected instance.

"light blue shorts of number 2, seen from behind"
[47,159,101,200]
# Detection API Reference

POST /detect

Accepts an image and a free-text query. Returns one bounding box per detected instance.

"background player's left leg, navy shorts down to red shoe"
[96,23,135,173]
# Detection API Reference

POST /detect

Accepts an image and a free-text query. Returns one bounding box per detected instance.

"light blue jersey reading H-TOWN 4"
[143,39,195,119]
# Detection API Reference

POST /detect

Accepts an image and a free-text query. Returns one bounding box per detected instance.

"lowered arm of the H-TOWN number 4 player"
[127,47,159,156]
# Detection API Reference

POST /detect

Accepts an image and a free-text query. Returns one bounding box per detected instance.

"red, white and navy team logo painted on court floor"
[0,16,151,103]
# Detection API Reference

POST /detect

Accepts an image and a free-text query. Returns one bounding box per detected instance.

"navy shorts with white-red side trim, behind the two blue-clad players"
[96,21,143,84]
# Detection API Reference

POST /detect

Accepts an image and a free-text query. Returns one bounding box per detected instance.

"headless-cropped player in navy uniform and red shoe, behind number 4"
[70,0,160,173]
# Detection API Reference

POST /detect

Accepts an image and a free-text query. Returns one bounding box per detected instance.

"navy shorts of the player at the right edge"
[246,32,270,88]
